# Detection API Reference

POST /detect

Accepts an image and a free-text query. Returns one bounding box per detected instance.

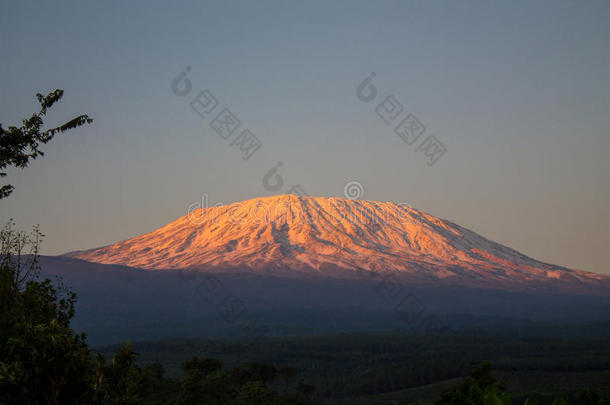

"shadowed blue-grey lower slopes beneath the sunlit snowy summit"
[40,256,610,345]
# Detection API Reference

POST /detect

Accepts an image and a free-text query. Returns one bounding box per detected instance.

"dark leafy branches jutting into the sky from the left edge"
[0,89,93,199]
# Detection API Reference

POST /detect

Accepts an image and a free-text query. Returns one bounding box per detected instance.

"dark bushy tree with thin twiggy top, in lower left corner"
[0,221,94,404]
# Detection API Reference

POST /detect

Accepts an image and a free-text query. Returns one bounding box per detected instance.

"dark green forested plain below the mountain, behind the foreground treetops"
[96,332,610,404]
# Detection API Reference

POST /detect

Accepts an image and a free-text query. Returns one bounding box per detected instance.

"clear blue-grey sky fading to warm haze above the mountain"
[0,0,610,274]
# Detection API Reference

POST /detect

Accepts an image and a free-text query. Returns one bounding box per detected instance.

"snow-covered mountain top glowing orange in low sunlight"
[66,195,610,294]
